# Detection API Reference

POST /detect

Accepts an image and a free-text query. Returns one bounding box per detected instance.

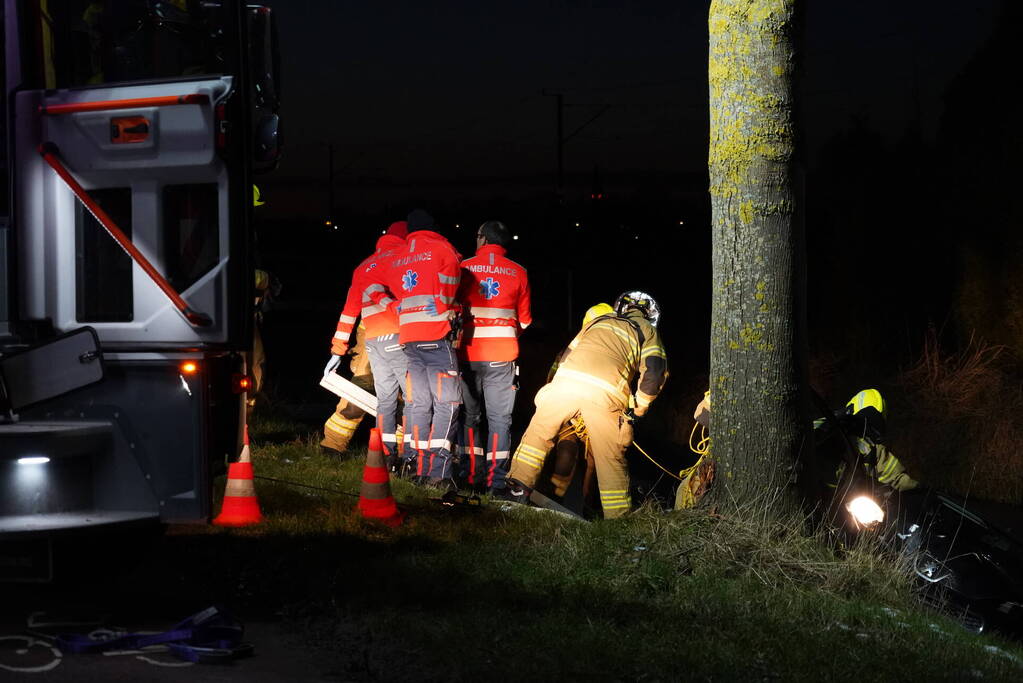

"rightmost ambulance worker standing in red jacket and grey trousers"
[458,221,533,491]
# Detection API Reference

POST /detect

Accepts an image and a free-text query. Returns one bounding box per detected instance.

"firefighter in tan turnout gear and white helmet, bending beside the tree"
[504,291,668,518]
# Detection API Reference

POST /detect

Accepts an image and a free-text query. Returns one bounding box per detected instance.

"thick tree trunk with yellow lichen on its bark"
[709,0,808,506]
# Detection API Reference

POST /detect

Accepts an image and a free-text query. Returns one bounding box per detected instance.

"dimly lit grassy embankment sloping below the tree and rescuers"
[165,411,1023,682]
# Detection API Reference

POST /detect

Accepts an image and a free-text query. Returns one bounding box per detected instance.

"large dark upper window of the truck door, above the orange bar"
[31,0,226,88]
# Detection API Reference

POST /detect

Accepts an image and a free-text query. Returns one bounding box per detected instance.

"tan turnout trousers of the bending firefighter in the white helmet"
[508,377,632,519]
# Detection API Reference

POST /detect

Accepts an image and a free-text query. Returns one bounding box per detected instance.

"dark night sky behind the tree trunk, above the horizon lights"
[255,0,999,218]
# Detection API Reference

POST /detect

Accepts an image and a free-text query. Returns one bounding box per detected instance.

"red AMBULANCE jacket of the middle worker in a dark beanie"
[384,230,461,344]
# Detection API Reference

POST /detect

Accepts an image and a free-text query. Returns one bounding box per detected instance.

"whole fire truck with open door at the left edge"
[0,0,280,580]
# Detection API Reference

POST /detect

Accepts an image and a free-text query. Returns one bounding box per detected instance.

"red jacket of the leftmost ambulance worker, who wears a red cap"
[333,235,405,346]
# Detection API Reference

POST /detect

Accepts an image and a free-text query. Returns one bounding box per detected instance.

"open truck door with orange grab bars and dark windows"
[8,0,253,350]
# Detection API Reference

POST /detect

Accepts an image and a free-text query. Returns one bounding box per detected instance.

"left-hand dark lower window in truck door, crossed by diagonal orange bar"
[75,187,135,322]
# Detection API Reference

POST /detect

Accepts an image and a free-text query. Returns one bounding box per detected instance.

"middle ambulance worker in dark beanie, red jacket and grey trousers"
[372,209,461,489]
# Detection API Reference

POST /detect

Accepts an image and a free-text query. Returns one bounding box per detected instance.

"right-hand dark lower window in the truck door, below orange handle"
[163,183,220,291]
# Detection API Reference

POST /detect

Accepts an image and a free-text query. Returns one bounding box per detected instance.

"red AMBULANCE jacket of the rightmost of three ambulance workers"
[458,244,533,361]
